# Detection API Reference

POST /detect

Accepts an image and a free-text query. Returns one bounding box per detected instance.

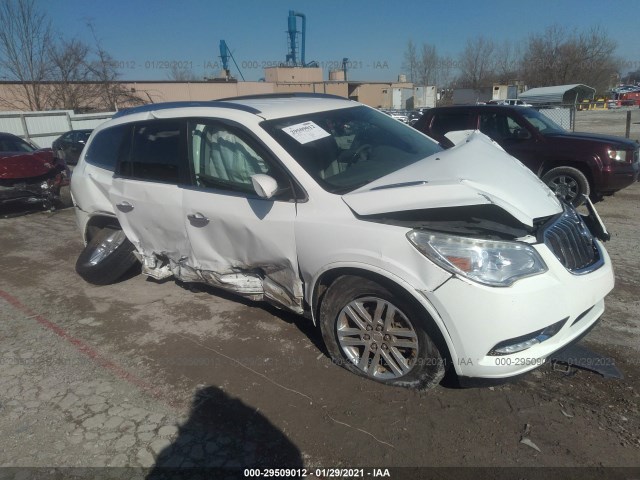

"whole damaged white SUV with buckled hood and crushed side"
[72,95,614,388]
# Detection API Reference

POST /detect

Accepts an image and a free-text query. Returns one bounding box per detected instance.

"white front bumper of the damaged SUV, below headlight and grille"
[422,240,614,379]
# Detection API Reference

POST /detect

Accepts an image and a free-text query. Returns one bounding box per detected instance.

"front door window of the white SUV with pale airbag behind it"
[189,121,292,199]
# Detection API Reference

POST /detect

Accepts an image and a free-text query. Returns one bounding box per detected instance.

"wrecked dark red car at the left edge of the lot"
[0,133,69,208]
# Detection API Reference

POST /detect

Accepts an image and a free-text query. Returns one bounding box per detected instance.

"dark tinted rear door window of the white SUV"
[118,120,186,184]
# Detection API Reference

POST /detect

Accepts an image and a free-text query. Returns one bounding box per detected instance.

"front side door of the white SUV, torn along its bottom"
[183,119,302,311]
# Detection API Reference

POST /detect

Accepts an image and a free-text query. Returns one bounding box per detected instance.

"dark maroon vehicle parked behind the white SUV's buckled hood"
[414,105,640,204]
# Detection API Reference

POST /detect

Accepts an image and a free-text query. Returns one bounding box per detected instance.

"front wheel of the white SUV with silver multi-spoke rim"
[320,276,445,389]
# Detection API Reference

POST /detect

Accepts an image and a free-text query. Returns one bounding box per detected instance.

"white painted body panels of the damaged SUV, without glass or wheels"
[72,98,613,378]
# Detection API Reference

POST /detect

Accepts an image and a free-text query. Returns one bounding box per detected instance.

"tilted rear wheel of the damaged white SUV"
[76,227,138,285]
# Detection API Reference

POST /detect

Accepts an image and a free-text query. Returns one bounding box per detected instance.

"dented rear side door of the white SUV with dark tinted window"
[109,120,189,268]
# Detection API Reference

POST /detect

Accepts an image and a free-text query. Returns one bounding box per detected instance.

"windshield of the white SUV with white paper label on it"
[262,106,442,194]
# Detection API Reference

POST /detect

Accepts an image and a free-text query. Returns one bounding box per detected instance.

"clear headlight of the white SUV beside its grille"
[407,230,547,287]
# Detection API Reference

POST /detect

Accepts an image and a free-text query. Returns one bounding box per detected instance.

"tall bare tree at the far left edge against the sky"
[0,0,53,110]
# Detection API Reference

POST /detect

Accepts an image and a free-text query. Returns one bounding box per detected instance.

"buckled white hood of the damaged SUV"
[342,132,562,226]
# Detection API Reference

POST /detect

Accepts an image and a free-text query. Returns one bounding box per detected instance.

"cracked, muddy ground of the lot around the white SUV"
[0,107,640,478]
